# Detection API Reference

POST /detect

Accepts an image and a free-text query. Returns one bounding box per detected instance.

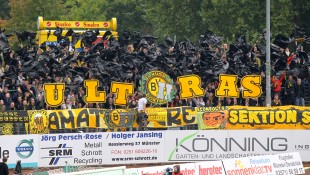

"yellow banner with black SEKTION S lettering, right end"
[227,106,310,129]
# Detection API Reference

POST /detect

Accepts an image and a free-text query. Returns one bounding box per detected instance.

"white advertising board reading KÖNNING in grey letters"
[165,130,310,162]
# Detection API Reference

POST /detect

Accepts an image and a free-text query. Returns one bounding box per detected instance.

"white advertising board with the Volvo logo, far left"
[0,135,40,168]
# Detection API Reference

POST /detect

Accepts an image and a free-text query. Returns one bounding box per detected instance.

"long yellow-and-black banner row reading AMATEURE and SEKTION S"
[0,106,310,135]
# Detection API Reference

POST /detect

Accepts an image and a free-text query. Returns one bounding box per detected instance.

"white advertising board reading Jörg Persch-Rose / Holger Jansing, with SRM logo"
[40,131,165,167]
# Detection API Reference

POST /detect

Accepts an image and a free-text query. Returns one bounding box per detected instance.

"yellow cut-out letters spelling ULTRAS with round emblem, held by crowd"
[44,71,262,107]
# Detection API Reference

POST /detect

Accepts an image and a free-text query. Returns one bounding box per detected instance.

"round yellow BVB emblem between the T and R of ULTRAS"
[139,71,177,104]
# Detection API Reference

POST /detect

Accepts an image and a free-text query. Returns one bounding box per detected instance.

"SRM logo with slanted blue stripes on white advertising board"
[41,144,72,165]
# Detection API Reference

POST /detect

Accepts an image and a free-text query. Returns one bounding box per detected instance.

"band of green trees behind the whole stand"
[0,0,310,43]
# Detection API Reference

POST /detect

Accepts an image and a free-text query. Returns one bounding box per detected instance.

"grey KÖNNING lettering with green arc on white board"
[168,131,288,161]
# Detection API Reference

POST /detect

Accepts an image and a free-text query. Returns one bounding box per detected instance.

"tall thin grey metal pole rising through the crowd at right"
[266,0,271,107]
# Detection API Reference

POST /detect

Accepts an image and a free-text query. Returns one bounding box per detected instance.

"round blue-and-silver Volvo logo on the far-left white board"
[15,139,34,159]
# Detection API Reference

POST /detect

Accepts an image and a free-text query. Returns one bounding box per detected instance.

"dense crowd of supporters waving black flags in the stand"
[0,28,310,110]
